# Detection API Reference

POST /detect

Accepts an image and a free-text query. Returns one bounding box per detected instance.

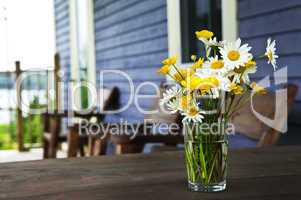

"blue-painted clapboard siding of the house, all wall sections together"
[55,0,301,128]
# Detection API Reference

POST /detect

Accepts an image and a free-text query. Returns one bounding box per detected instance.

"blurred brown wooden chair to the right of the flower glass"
[230,84,298,148]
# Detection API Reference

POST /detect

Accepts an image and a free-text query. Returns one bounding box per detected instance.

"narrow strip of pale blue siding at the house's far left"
[54,0,71,107]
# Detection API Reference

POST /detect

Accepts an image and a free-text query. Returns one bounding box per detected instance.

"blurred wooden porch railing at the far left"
[0,54,60,151]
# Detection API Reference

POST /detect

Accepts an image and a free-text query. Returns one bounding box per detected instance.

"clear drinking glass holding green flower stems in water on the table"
[183,119,228,192]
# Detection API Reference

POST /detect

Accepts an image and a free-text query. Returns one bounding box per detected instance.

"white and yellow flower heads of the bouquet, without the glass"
[158,30,278,122]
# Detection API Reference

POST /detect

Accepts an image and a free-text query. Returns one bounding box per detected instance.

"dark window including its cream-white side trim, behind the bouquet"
[167,0,237,67]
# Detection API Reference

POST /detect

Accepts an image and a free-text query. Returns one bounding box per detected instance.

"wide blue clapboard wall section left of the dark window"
[94,0,168,122]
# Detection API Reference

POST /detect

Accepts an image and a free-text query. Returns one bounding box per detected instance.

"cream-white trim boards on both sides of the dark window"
[167,0,238,68]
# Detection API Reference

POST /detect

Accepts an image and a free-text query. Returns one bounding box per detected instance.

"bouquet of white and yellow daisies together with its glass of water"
[158,30,278,191]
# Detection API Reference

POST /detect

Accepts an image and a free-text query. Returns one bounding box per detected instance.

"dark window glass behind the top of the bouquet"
[180,0,222,63]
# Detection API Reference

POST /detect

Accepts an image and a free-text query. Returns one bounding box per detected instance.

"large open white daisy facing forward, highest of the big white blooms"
[219,39,252,70]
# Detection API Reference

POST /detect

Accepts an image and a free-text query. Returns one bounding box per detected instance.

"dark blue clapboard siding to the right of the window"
[238,0,301,129]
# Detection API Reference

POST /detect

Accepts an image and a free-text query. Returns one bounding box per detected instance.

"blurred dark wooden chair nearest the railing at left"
[42,87,119,158]
